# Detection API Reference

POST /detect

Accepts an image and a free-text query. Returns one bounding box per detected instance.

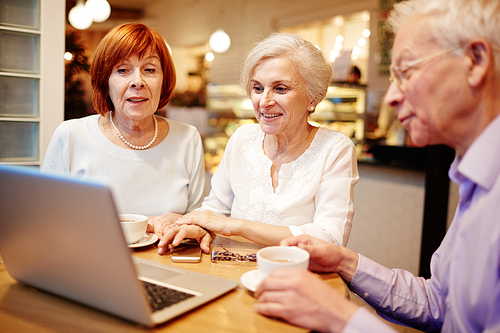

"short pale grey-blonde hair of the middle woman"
[240,32,332,103]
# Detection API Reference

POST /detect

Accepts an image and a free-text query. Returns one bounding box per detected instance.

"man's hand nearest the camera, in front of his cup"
[254,269,358,332]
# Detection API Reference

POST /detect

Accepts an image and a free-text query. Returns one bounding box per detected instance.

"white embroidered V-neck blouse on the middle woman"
[199,124,359,245]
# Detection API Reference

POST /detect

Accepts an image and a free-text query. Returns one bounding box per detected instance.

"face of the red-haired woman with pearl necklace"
[109,54,163,120]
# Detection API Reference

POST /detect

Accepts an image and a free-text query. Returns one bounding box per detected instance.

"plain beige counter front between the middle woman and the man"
[347,164,425,274]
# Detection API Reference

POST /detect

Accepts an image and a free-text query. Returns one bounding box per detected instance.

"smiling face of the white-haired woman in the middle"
[250,57,314,135]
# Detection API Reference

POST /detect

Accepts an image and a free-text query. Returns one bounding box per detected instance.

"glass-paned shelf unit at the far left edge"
[0,0,41,164]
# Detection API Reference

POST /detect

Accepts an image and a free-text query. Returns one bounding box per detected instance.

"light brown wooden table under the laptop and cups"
[0,236,349,333]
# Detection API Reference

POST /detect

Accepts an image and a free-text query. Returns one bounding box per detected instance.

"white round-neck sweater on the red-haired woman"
[42,115,205,216]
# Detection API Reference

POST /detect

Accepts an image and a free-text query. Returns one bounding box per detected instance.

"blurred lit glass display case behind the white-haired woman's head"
[203,83,366,174]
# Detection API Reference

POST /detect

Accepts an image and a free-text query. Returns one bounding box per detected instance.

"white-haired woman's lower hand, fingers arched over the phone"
[158,225,212,254]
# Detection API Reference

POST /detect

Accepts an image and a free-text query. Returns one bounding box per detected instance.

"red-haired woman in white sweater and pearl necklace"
[42,23,205,236]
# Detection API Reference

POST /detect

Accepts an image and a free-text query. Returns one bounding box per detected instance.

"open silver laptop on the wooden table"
[0,165,239,327]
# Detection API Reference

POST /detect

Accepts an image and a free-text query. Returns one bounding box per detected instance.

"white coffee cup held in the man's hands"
[257,246,309,278]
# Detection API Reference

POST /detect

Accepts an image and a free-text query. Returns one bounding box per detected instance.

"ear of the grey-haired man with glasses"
[465,38,494,87]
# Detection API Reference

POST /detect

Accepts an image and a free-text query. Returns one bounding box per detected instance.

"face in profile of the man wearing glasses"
[385,15,467,146]
